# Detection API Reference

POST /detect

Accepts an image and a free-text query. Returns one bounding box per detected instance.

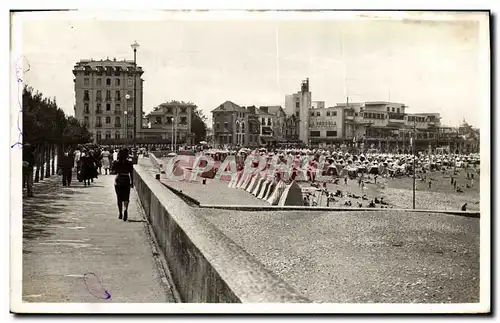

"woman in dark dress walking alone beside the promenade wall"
[111,148,134,221]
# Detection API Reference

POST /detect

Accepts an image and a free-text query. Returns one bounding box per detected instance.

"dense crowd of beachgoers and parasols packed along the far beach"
[196,148,480,210]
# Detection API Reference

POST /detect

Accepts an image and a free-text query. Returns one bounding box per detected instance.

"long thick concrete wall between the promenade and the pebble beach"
[134,165,310,303]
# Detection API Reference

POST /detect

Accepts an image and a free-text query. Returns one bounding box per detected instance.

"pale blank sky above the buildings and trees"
[13,13,489,127]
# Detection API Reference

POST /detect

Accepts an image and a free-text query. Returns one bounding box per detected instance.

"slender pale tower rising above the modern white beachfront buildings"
[285,78,311,144]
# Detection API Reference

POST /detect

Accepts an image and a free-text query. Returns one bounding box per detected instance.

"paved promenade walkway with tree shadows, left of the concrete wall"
[23,175,173,303]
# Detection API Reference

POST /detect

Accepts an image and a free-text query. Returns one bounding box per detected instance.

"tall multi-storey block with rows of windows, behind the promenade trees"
[73,59,144,143]
